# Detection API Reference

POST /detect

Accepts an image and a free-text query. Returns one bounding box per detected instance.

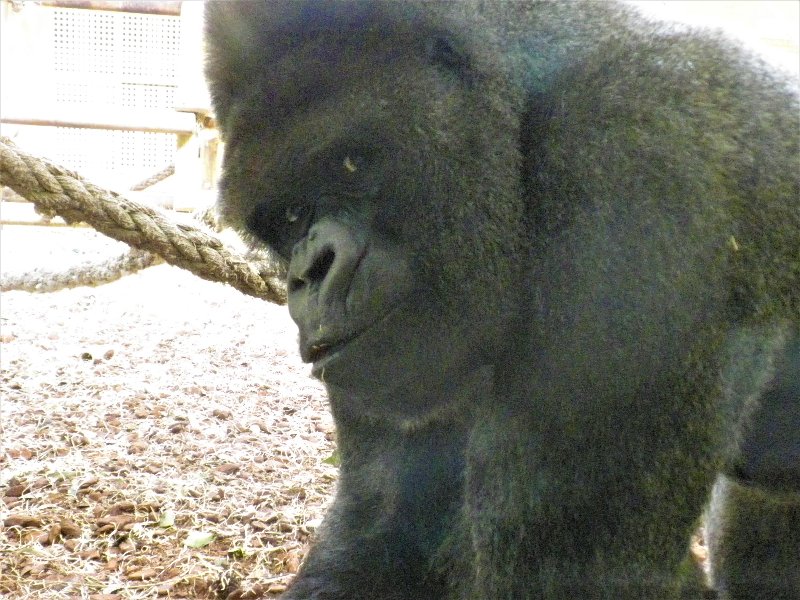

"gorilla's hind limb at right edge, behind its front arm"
[706,332,800,599]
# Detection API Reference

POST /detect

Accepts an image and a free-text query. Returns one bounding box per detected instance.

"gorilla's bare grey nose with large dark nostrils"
[288,219,364,327]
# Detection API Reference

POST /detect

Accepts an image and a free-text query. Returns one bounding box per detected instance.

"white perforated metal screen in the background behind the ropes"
[8,7,184,189]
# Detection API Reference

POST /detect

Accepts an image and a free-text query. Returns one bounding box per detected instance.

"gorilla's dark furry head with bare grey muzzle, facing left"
[210,4,523,419]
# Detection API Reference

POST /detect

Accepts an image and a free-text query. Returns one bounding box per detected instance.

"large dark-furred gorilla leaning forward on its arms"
[206,0,800,600]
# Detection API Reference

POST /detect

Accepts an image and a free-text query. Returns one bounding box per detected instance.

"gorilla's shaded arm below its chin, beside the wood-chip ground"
[285,400,477,600]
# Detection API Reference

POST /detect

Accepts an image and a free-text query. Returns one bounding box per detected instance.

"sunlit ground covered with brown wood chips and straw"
[0,227,337,600]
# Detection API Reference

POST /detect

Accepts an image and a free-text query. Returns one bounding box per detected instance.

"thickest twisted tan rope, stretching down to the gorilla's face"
[0,137,286,304]
